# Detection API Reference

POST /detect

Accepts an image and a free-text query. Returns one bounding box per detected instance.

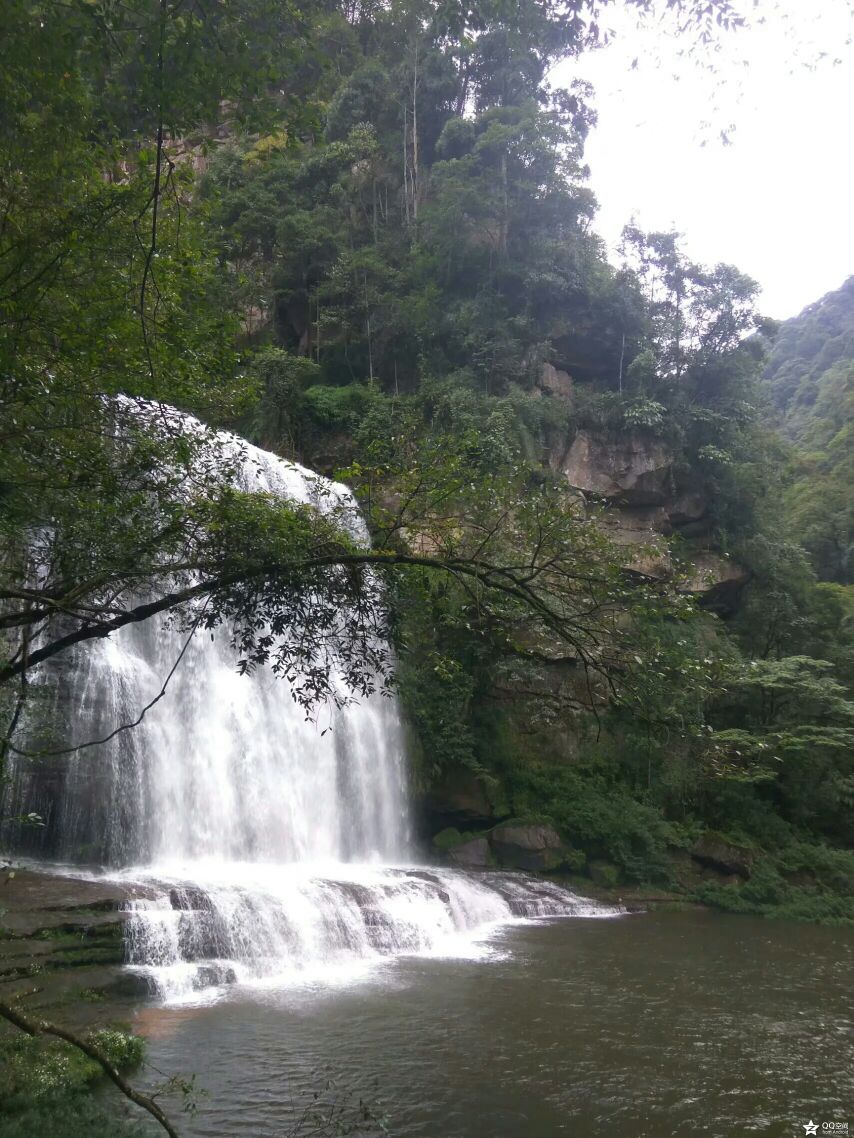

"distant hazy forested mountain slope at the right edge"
[764,277,854,584]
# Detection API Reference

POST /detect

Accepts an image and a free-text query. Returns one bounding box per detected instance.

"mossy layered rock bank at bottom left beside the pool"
[0,866,155,1138]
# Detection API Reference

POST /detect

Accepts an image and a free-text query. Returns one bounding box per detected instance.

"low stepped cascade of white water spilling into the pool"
[122,863,621,1001]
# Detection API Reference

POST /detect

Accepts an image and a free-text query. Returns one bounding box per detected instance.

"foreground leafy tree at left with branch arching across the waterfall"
[0,0,674,764]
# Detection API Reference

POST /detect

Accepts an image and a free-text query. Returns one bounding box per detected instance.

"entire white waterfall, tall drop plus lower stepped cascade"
[5,412,613,999]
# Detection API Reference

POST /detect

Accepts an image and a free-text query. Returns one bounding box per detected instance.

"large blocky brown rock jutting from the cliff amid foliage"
[560,430,673,505]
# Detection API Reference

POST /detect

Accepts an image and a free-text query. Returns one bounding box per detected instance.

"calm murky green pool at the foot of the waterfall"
[139,913,854,1138]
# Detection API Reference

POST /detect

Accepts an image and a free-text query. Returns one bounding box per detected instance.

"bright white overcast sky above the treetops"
[552,0,854,319]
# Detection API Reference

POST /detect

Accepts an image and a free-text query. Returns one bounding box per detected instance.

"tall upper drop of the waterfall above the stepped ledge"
[12,409,410,867]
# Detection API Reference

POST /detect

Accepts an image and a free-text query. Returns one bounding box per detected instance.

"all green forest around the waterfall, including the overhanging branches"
[0,0,854,946]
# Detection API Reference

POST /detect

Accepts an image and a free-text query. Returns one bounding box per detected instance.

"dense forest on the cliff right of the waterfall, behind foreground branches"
[184,6,854,918]
